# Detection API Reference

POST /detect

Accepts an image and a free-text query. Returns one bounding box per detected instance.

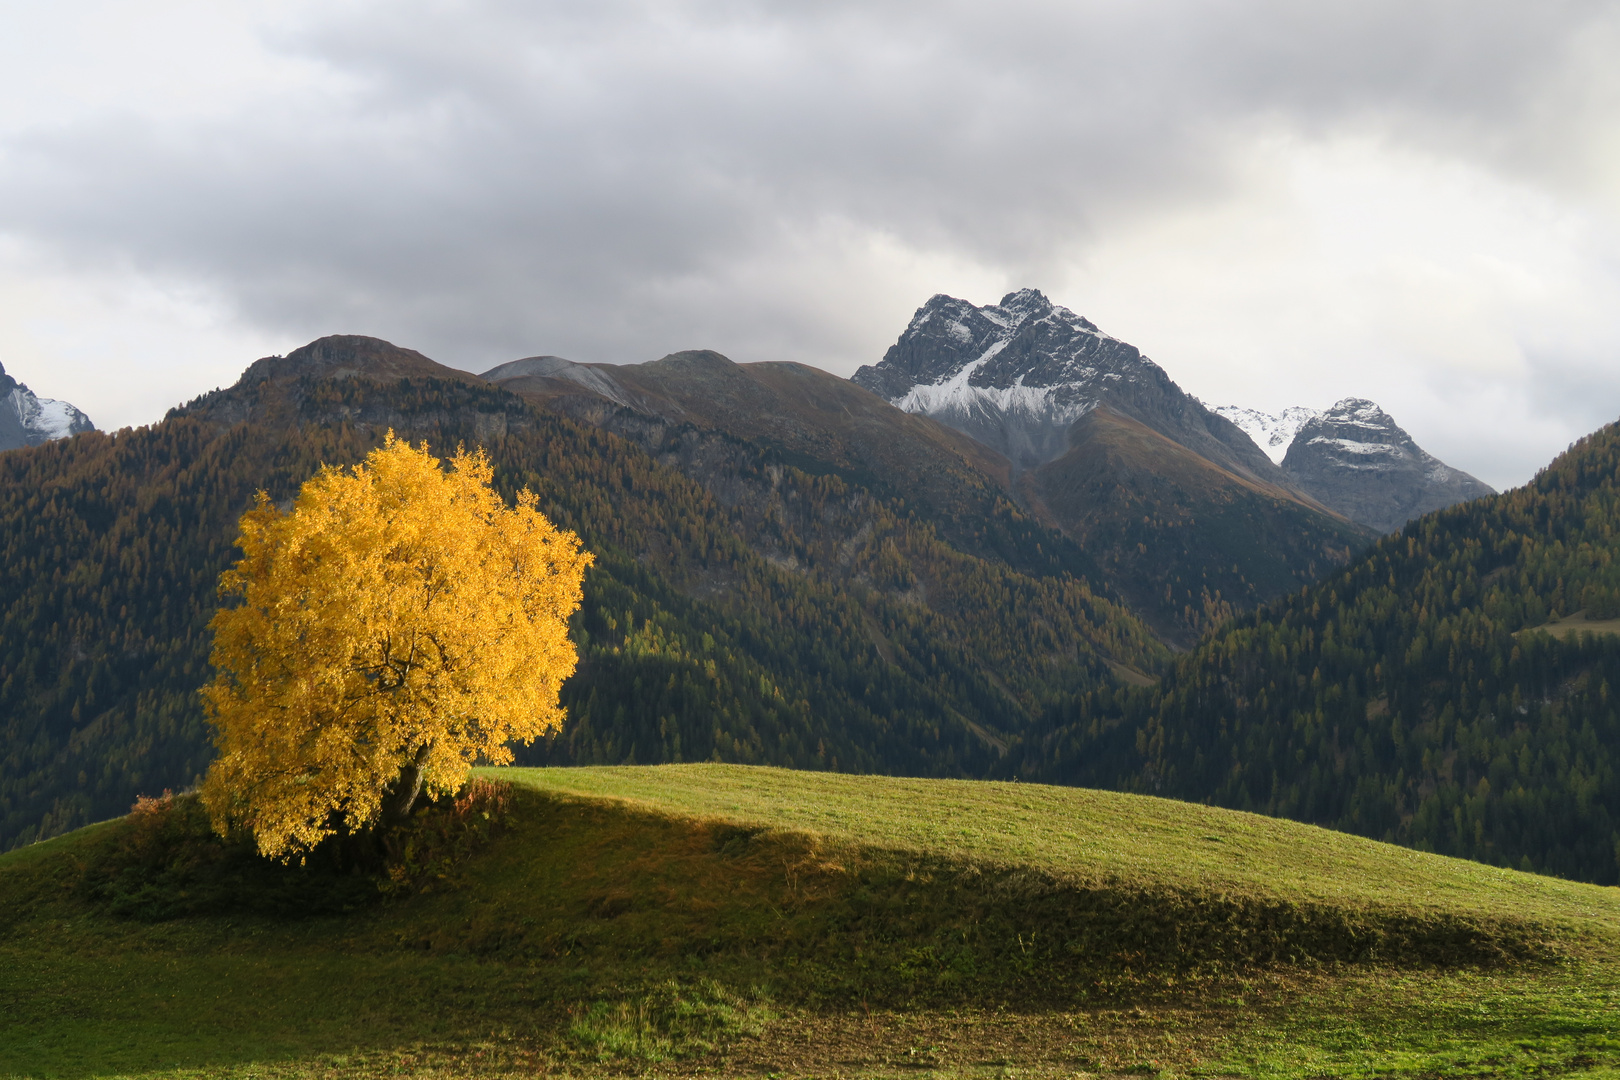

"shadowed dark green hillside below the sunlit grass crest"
[0,790,1552,1077]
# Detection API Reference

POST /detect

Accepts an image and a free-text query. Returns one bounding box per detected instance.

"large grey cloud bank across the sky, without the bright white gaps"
[0,0,1614,380]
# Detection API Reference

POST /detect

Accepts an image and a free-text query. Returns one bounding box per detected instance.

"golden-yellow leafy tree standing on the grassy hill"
[203,432,591,860]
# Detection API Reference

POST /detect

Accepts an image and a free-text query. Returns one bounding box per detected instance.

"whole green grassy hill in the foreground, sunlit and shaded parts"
[0,766,1620,1077]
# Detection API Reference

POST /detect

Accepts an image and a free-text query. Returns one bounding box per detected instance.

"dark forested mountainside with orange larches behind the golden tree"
[0,338,1165,847]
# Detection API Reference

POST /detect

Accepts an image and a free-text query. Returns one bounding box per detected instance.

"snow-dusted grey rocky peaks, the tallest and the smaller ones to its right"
[854,288,1492,533]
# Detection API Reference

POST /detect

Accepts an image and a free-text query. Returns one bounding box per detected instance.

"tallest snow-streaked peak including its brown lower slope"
[854,288,1371,644]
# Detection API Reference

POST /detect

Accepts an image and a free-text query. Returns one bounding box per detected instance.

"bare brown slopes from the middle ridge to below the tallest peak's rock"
[484,338,1371,646]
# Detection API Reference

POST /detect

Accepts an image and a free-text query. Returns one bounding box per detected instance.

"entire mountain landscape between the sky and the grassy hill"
[0,290,1620,882]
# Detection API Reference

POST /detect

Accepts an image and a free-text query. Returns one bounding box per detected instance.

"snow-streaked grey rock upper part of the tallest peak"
[854,288,1286,484]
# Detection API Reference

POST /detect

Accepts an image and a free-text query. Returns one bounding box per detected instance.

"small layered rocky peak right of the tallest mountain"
[1283,398,1495,533]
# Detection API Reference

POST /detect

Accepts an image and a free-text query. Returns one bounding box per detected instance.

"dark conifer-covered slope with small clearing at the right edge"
[1014,424,1620,884]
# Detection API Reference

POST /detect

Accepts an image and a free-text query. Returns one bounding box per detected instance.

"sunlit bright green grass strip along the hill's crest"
[486,764,1620,939]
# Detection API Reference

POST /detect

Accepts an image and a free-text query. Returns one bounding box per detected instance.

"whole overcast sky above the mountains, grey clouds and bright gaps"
[0,0,1620,487]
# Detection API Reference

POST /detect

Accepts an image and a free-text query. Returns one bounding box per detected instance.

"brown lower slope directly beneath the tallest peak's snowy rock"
[1019,406,1369,644]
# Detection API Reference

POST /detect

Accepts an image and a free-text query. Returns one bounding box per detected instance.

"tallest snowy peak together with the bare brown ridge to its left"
[483,290,1445,648]
